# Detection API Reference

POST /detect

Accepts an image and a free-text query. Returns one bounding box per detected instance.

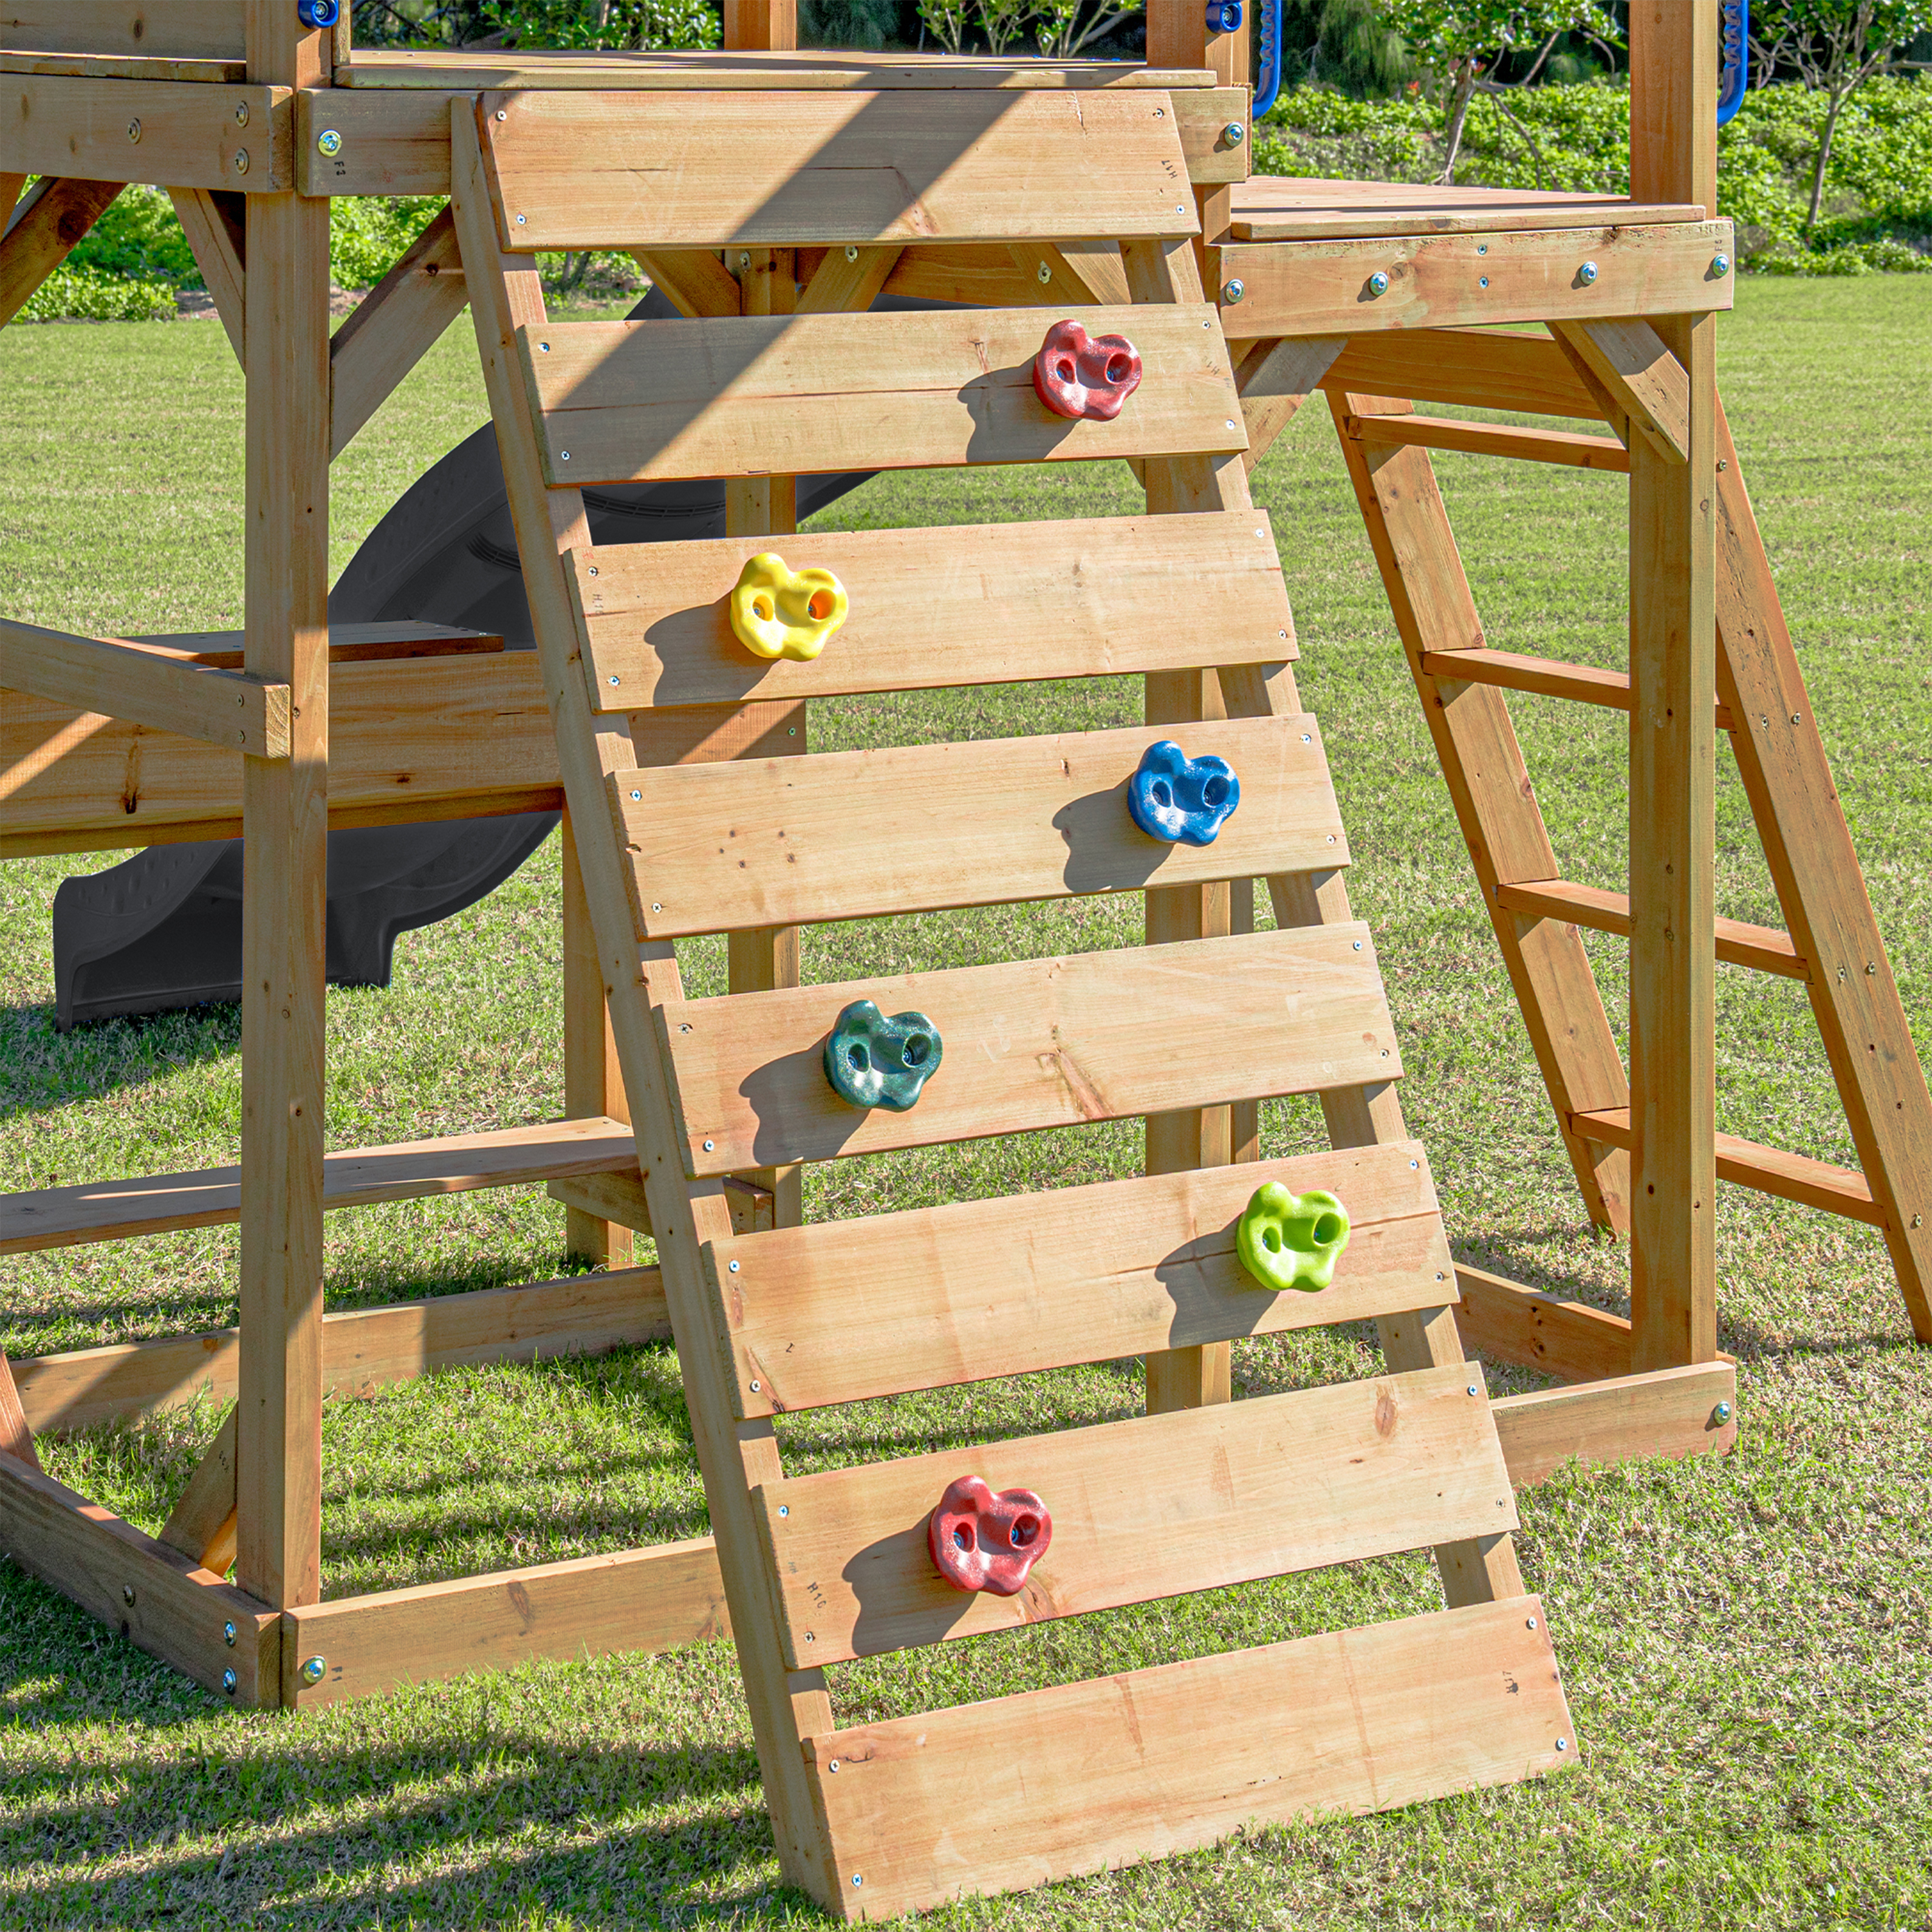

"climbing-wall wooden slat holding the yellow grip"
[570,510,1296,711]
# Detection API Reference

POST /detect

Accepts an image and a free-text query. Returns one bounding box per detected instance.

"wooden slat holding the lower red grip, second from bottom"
[757,1366,1517,1669]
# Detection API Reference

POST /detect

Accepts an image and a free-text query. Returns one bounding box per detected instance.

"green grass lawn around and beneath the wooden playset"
[0,276,1932,1928]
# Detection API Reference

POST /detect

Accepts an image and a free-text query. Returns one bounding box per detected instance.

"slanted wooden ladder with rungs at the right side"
[1298,336,1932,1343]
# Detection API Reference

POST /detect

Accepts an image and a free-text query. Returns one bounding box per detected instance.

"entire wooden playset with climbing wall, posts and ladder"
[0,0,1932,1917]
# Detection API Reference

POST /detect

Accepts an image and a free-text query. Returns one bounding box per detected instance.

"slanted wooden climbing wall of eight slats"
[452,91,1575,1918]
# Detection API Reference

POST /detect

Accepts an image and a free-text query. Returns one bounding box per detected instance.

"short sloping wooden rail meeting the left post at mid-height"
[0,618,290,759]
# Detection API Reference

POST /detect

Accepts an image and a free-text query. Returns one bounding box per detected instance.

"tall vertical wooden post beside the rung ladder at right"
[1631,0,1718,1372]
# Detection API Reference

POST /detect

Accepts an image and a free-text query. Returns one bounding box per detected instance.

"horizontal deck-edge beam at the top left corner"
[0,73,294,193]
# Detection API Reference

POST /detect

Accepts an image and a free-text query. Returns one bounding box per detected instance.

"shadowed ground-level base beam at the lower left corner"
[0,1453,282,1710]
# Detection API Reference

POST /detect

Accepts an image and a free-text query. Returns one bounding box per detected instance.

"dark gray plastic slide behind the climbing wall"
[54,290,877,1032]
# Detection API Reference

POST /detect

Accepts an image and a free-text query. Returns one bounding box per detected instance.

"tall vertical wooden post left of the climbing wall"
[236,0,328,1609]
